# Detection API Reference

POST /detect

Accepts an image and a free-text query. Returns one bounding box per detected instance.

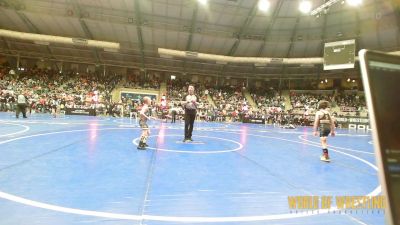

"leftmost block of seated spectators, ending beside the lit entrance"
[0,64,121,113]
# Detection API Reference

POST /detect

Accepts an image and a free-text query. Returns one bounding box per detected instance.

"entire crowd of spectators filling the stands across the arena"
[0,64,366,125]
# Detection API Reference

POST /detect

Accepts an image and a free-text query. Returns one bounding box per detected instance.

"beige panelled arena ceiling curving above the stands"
[0,0,400,76]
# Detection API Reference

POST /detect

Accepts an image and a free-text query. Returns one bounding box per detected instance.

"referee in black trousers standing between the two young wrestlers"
[183,85,197,142]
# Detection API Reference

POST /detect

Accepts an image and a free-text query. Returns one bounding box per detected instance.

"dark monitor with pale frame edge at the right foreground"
[359,50,400,225]
